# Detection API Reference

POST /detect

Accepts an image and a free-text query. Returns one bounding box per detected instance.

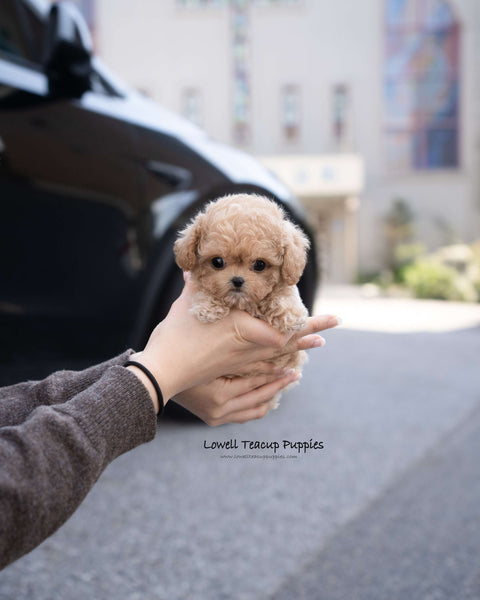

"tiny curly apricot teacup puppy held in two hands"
[174,194,309,408]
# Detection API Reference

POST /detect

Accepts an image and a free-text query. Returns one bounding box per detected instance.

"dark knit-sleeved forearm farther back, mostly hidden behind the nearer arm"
[0,350,133,426]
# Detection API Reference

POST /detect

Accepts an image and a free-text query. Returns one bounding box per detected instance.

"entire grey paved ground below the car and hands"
[0,297,480,600]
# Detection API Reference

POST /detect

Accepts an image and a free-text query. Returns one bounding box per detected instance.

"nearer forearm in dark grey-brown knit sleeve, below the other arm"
[0,366,156,568]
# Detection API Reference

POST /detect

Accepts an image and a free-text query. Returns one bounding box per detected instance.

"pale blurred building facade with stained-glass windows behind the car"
[91,0,480,281]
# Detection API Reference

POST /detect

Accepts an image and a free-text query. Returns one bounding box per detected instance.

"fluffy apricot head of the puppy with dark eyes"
[174,194,309,308]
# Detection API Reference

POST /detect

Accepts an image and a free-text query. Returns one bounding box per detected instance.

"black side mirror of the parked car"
[45,2,92,97]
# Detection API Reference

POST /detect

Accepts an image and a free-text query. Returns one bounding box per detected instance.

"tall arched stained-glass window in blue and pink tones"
[384,0,460,172]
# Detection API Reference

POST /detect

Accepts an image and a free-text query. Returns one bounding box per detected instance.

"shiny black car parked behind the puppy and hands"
[0,0,316,380]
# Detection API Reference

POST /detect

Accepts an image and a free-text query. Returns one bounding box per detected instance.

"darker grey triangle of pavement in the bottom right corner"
[271,398,480,600]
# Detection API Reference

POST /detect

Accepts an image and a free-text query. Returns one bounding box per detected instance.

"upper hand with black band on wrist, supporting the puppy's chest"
[129,277,337,410]
